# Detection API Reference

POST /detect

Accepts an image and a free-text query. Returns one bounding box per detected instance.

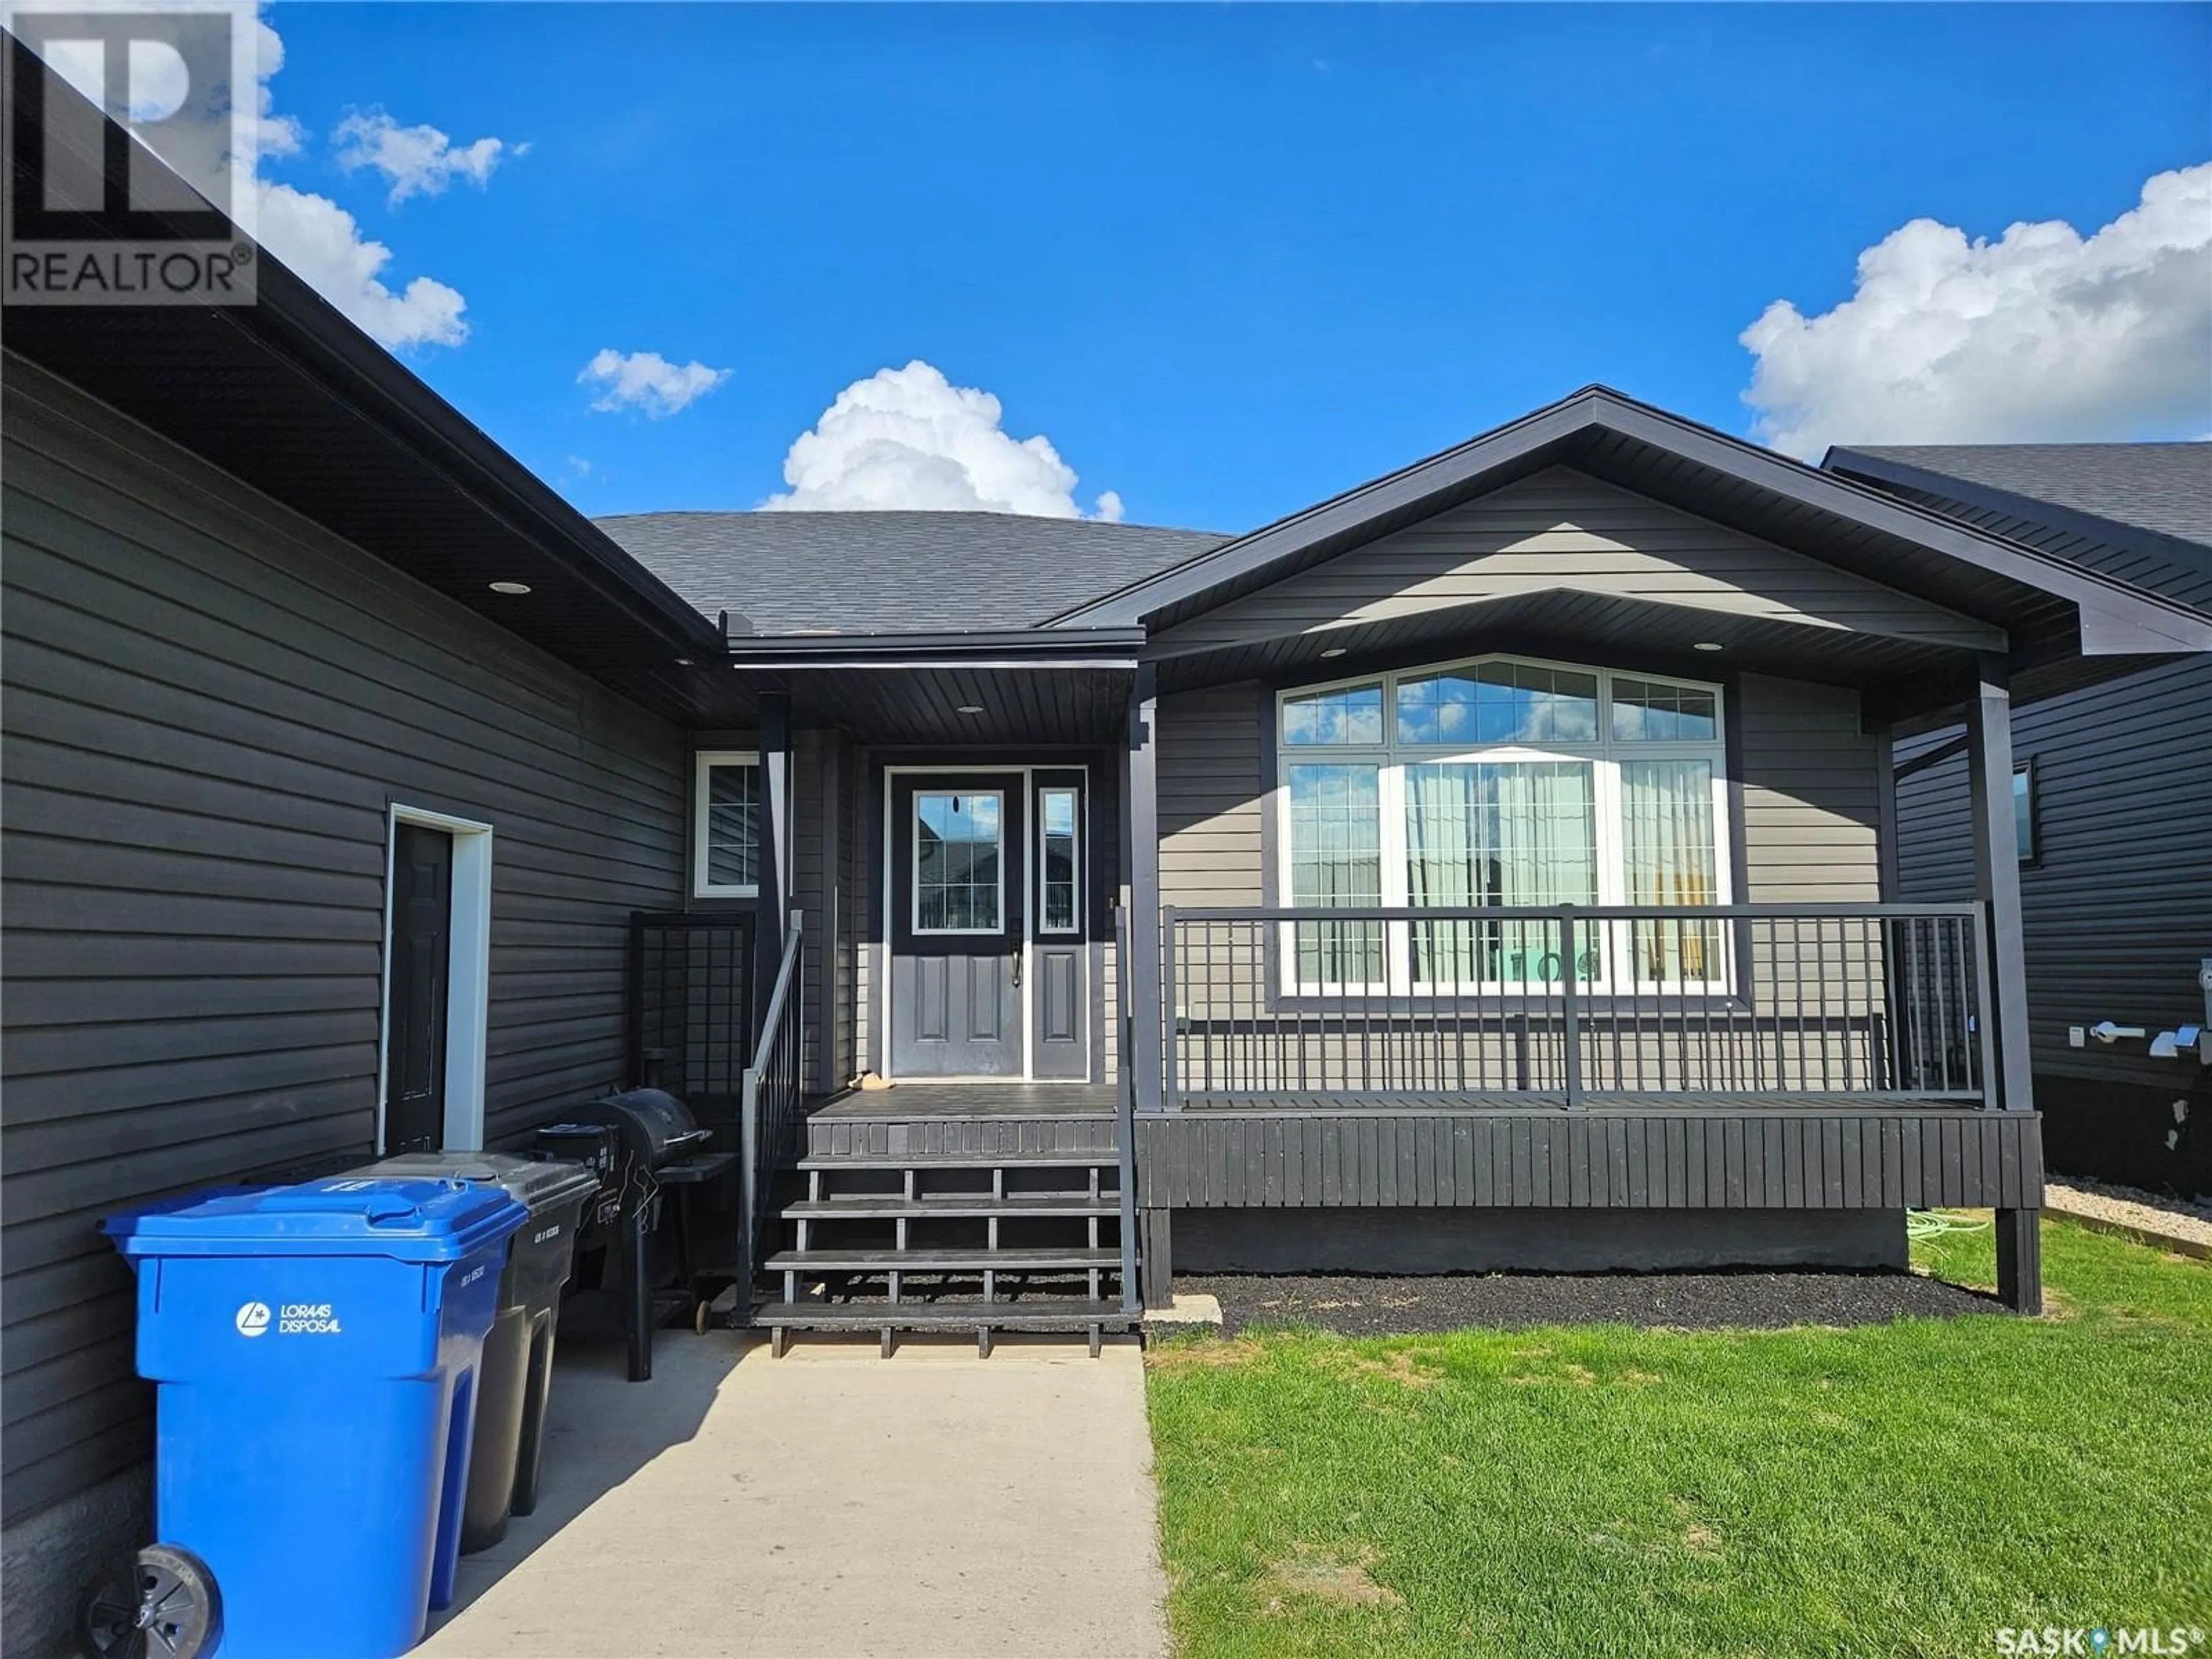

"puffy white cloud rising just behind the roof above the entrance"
[761,361,1122,522]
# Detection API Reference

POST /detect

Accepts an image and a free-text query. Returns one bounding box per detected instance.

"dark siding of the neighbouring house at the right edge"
[1898,659,2212,1097]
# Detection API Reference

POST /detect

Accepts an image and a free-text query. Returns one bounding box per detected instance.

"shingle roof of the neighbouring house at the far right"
[1847,442,2212,546]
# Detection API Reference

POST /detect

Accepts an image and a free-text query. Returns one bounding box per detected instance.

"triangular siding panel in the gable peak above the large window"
[1161,467,2002,650]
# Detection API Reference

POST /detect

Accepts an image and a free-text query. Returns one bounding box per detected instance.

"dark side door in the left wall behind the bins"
[382,823,453,1153]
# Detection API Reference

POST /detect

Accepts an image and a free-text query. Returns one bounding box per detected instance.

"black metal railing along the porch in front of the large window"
[1161,905,1993,1111]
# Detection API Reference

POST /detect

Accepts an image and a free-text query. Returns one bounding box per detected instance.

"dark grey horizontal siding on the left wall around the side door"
[0,358,685,1520]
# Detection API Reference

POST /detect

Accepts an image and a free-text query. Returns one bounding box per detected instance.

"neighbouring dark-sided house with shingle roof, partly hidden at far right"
[1823,442,2212,1195]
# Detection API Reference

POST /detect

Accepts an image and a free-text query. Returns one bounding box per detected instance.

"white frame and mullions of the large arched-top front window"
[1274,653,1734,998]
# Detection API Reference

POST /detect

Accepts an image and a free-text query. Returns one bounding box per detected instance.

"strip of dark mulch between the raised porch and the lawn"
[1175,1272,1999,1336]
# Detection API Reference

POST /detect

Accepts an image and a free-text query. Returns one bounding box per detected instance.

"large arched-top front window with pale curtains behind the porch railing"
[1277,657,1728,991]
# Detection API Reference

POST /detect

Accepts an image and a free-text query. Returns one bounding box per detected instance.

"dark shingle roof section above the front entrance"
[597,513,1228,635]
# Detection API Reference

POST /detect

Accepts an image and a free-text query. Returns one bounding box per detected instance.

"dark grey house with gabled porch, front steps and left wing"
[13,97,2212,1652]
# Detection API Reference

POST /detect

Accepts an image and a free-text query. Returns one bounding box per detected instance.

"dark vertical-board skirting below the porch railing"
[1137,1106,2044,1210]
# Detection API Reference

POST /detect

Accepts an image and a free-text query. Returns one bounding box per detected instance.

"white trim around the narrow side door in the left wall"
[376,801,491,1153]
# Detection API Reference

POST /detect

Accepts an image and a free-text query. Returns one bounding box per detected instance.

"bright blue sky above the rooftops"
[263,5,2212,529]
